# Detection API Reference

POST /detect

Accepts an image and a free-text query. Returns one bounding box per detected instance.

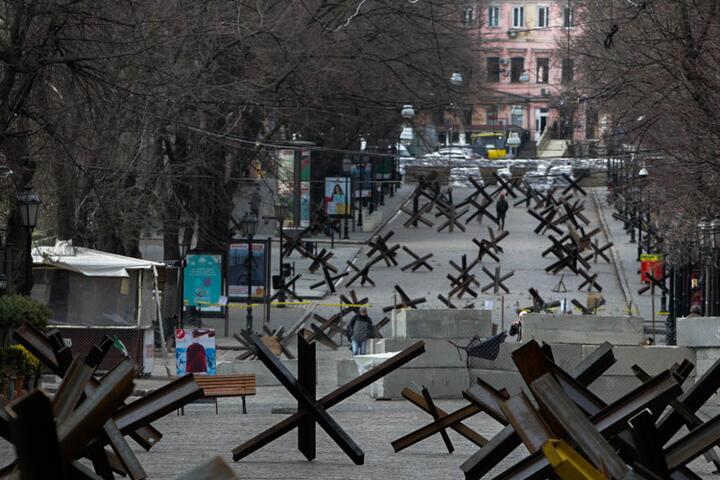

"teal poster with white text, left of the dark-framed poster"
[183,253,223,312]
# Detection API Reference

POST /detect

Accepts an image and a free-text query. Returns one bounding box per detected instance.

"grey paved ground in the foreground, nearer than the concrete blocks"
[0,346,717,480]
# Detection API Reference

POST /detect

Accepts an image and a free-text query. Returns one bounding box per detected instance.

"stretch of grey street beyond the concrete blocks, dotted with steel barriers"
[318,183,626,325]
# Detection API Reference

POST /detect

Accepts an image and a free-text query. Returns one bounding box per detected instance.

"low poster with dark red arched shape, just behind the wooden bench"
[175,328,217,377]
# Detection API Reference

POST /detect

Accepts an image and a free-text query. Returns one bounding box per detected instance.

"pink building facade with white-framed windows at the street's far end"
[462,0,577,149]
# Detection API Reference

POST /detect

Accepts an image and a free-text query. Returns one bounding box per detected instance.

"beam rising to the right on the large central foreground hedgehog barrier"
[232,341,425,461]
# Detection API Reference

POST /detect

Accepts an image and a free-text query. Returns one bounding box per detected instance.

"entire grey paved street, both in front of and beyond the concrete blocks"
[0,181,713,479]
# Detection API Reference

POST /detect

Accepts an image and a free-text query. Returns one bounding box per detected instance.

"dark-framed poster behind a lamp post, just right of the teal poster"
[227,241,268,300]
